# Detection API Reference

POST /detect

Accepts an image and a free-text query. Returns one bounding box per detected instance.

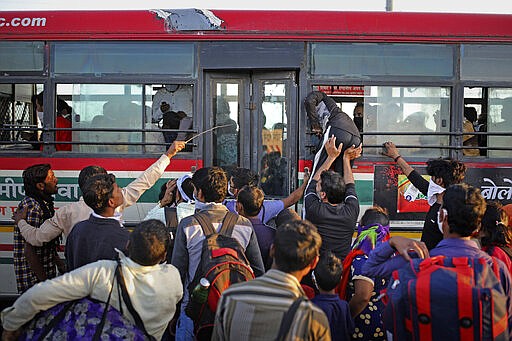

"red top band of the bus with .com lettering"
[0,9,512,42]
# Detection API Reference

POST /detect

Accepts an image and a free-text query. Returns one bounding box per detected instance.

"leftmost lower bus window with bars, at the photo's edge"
[0,83,43,150]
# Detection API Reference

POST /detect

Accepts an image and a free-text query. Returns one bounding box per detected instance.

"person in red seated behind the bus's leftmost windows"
[33,91,72,151]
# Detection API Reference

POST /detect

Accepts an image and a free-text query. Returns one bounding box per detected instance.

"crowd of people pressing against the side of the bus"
[1,90,512,340]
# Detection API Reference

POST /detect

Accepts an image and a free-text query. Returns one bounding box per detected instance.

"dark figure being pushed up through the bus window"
[304,91,361,176]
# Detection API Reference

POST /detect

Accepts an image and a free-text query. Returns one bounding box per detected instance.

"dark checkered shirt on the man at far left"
[13,197,60,292]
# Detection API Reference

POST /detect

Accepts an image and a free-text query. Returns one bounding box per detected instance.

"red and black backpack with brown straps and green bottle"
[185,212,254,340]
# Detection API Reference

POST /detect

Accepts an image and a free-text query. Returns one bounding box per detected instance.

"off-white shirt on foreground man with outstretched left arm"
[1,248,183,340]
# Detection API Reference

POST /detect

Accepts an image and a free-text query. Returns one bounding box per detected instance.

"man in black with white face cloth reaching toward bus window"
[382,142,466,250]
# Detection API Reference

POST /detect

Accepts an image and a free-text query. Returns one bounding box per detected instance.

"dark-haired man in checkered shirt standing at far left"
[14,164,64,293]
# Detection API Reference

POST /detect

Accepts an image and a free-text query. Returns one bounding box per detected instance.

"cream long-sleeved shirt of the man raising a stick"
[18,155,170,246]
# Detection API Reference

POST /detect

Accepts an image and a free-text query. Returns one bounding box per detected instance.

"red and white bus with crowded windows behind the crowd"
[0,9,512,293]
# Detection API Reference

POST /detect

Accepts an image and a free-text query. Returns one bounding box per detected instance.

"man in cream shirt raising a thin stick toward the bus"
[12,141,185,246]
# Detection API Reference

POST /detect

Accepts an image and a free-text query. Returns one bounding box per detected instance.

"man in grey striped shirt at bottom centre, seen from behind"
[212,221,331,340]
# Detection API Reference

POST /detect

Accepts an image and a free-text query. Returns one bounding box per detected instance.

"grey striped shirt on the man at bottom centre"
[212,269,331,341]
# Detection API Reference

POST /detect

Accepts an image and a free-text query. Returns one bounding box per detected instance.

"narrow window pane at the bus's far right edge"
[487,88,512,158]
